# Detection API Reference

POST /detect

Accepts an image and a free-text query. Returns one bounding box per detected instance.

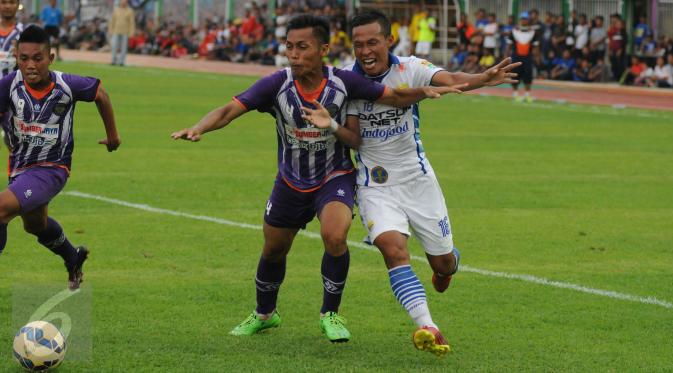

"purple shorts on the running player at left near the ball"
[9,166,68,214]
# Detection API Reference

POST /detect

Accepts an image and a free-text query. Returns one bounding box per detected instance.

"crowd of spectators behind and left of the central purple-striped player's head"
[49,2,352,66]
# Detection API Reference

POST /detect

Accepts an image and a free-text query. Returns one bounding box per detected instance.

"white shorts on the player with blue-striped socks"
[357,173,453,255]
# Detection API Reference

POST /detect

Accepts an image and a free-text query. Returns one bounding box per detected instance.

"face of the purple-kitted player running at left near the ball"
[16,43,54,87]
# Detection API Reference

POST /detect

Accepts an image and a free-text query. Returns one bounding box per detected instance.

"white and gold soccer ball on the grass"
[14,321,66,371]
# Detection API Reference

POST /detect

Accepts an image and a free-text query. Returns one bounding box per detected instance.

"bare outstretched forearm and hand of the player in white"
[430,58,521,91]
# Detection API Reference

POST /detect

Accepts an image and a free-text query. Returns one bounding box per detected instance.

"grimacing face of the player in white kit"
[353,22,393,76]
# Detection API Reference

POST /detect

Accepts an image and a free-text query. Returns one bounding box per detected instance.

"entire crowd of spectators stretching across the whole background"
[28,0,673,87]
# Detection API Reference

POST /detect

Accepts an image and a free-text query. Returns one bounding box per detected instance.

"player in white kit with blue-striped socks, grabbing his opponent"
[347,11,518,355]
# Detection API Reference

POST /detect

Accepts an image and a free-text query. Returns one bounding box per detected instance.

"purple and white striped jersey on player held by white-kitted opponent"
[234,66,385,191]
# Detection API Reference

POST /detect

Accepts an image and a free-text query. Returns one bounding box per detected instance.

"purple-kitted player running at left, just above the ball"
[0,26,120,290]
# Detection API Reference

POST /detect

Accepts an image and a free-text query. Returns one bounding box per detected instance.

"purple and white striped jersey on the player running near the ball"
[0,71,100,177]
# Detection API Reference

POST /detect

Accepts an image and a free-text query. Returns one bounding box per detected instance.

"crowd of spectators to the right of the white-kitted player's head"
[449,9,673,87]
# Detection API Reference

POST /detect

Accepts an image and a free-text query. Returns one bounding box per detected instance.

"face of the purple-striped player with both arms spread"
[285,27,329,77]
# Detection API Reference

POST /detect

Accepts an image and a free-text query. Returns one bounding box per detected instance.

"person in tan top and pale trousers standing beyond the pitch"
[108,0,136,66]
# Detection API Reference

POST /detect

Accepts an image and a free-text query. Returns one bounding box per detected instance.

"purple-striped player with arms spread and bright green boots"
[172,15,459,342]
